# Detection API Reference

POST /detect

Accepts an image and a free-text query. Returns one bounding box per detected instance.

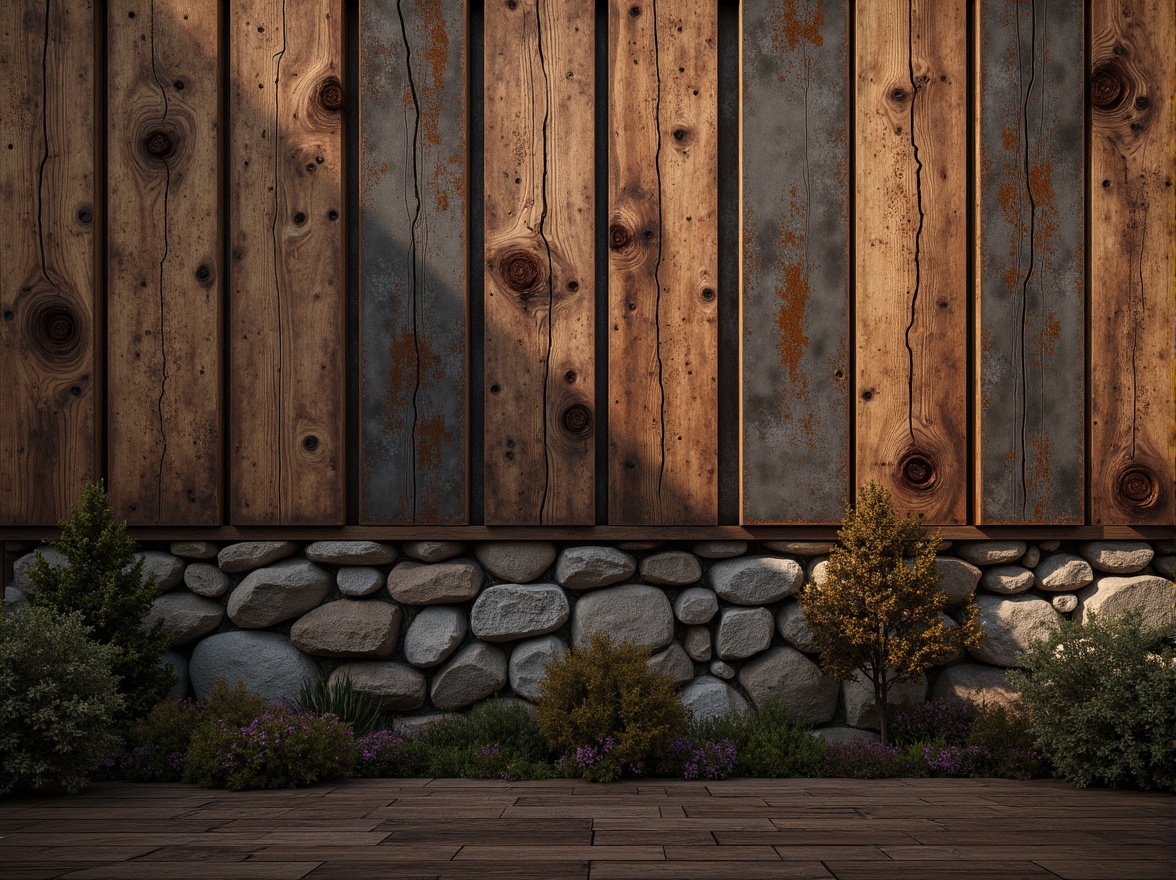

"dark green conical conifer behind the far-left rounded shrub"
[28,482,175,726]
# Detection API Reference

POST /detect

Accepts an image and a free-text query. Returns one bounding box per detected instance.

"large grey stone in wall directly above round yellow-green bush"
[572,584,674,651]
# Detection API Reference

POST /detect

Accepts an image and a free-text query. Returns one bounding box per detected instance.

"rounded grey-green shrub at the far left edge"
[0,607,123,794]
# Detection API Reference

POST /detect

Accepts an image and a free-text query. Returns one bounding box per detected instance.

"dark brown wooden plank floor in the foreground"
[0,779,1172,880]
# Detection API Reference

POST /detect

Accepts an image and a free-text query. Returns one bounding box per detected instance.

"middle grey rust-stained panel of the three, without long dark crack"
[742,0,850,524]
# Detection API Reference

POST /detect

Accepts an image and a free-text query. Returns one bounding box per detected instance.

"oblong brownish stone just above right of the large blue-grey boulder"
[290,599,401,659]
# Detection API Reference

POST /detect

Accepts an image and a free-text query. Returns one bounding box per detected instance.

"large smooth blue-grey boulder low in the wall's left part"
[188,629,319,702]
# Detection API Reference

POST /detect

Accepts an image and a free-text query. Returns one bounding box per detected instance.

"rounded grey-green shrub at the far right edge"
[1009,612,1176,791]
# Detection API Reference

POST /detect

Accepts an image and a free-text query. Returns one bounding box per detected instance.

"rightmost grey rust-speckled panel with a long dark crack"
[976,0,1085,522]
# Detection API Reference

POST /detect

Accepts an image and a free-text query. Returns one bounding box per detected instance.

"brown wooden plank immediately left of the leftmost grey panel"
[229,0,346,525]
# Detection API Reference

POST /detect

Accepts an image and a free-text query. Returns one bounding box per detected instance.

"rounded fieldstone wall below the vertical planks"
[5,541,1176,736]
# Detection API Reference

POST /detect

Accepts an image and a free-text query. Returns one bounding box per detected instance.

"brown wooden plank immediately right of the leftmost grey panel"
[485,0,595,525]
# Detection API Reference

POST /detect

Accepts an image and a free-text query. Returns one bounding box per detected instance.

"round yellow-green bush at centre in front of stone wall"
[536,633,687,781]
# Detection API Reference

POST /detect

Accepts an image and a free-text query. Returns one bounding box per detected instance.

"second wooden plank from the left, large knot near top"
[107,0,223,525]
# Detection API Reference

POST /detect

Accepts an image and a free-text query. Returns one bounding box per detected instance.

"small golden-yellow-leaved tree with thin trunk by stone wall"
[800,481,984,744]
